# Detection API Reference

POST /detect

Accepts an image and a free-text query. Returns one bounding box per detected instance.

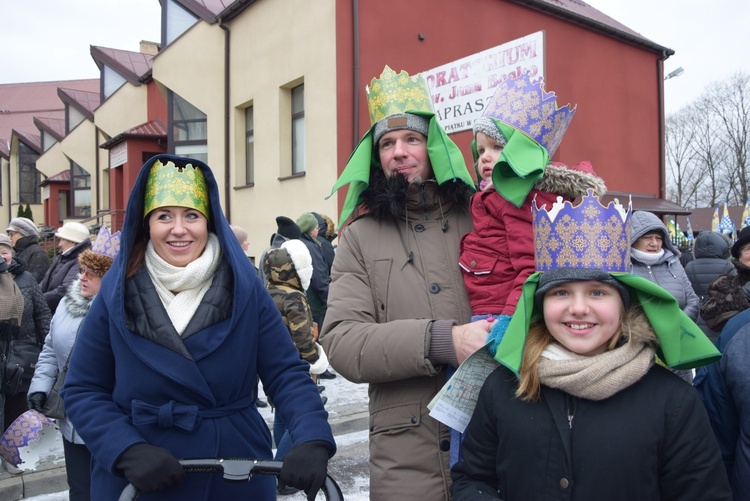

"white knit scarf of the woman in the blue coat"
[146,233,221,335]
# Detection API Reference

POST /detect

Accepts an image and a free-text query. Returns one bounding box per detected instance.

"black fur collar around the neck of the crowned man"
[362,168,473,221]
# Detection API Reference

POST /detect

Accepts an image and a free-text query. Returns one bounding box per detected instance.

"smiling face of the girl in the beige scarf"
[543,280,623,356]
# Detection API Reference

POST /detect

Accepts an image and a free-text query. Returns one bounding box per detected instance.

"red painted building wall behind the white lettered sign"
[336,0,662,219]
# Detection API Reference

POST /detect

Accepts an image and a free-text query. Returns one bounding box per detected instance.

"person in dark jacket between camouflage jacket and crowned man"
[297,212,331,329]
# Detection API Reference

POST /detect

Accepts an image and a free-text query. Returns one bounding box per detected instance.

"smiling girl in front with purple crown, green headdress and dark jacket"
[452,189,732,501]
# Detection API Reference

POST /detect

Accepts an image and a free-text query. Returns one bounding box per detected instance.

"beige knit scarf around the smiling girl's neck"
[538,340,654,400]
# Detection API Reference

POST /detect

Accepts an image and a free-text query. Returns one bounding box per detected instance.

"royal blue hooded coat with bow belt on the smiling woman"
[63,155,336,500]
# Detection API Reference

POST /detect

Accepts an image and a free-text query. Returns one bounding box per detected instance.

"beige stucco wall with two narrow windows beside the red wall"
[226,0,338,265]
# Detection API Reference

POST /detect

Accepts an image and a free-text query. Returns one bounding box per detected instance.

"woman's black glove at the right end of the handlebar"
[279,440,331,501]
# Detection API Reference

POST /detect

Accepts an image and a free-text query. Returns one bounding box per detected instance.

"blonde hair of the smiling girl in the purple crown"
[516,301,653,402]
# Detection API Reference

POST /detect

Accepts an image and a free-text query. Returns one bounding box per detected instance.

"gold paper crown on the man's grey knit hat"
[365,65,435,125]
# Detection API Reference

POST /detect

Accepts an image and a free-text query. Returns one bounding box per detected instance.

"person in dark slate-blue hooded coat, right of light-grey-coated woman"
[685,231,734,343]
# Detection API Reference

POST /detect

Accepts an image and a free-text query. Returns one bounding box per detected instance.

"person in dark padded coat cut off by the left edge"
[0,235,52,429]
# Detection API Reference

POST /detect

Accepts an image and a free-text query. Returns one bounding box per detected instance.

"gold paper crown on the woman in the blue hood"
[143,160,208,219]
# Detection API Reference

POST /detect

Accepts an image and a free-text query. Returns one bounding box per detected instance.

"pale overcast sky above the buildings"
[0,0,750,113]
